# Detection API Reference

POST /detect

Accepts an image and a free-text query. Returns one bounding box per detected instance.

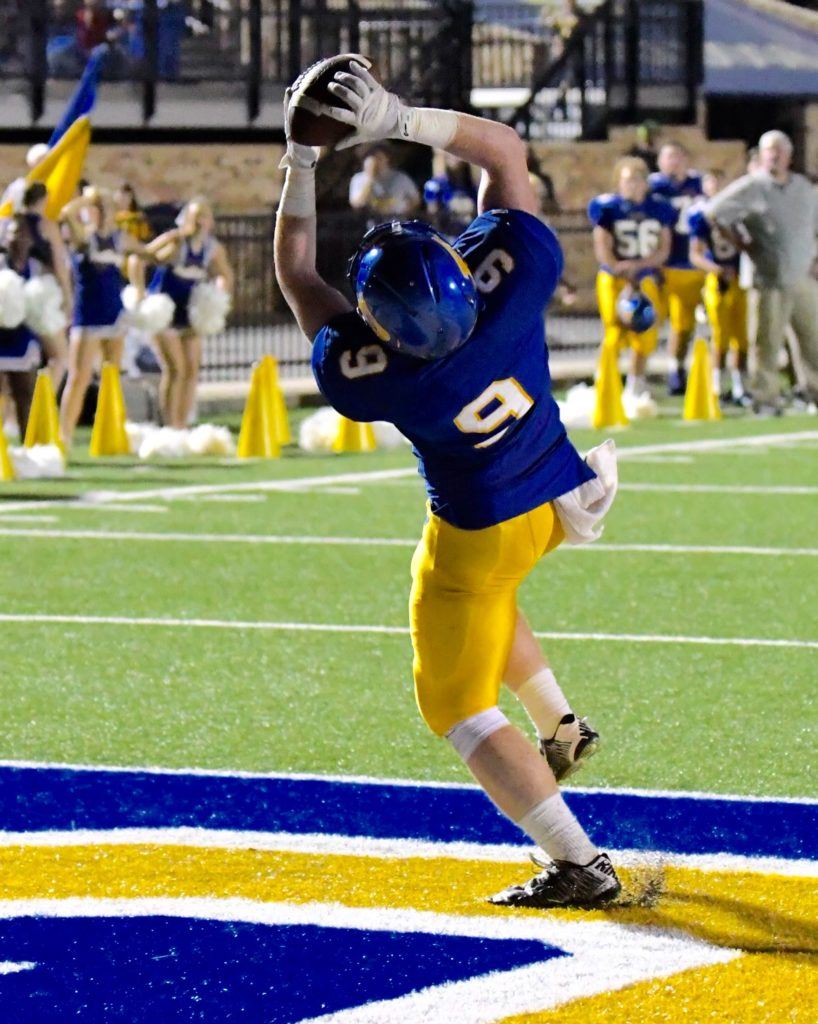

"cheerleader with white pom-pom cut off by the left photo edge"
[0,213,41,438]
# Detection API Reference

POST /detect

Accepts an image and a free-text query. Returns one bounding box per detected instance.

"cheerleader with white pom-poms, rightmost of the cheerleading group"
[145,197,233,429]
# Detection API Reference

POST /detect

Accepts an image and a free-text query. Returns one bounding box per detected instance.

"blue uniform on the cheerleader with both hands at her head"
[71,231,124,339]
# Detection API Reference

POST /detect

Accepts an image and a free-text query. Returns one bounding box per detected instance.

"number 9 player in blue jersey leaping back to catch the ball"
[275,57,620,907]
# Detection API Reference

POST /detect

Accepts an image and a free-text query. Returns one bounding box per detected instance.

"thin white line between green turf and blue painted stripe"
[0,759,818,806]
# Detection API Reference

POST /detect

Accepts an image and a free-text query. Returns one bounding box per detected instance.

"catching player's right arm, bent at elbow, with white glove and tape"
[327,61,539,213]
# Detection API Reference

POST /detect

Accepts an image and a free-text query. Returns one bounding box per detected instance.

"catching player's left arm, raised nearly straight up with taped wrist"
[274,97,352,341]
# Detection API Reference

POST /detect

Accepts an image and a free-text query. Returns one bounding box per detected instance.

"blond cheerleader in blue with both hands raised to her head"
[59,186,141,450]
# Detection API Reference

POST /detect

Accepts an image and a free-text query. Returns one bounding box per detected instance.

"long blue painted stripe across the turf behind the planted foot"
[0,767,818,860]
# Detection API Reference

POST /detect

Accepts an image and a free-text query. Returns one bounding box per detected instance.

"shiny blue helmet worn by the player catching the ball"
[349,220,478,359]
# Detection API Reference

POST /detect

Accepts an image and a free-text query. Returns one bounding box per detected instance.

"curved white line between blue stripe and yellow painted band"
[0,827,818,879]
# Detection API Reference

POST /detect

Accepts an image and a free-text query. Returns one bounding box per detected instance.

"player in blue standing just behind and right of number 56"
[648,142,704,394]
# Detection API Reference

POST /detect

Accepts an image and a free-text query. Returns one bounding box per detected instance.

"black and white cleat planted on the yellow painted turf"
[488,853,621,910]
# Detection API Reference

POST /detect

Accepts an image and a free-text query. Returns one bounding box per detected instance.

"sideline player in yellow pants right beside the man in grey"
[688,168,748,406]
